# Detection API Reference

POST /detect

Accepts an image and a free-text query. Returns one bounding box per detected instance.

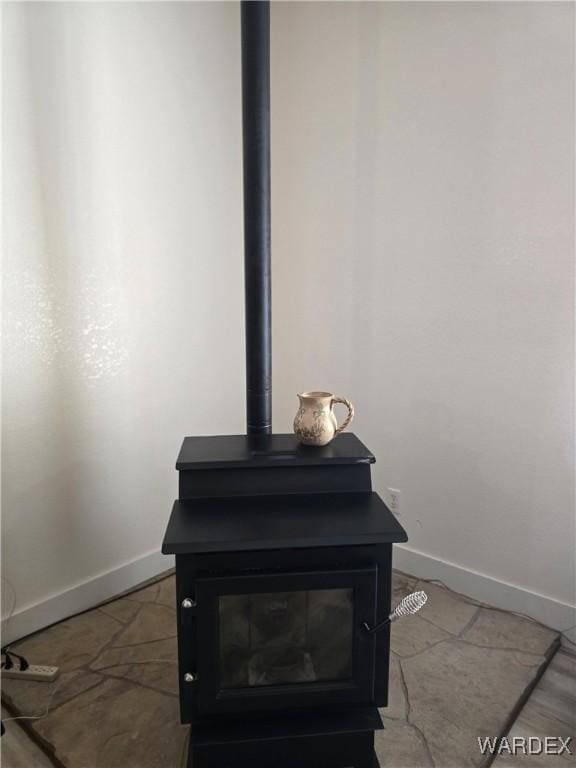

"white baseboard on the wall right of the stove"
[394,545,576,642]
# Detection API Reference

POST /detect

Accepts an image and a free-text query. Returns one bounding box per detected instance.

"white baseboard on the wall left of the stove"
[2,551,174,645]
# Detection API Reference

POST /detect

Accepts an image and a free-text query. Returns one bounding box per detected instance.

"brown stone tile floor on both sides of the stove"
[2,573,558,768]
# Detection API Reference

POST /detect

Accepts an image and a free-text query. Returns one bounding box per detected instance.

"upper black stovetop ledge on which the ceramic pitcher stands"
[176,432,376,470]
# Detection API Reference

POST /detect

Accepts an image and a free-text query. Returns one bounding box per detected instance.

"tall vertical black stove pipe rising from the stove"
[241,0,272,435]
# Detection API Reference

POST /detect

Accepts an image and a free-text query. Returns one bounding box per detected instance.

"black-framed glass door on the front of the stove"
[197,567,376,712]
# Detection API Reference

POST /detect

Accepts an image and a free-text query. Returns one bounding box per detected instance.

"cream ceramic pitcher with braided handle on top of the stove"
[294,392,354,445]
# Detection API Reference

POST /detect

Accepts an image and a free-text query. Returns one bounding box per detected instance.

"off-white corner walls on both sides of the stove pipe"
[3,3,574,634]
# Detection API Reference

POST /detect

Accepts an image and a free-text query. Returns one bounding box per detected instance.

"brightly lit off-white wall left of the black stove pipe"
[3,3,244,632]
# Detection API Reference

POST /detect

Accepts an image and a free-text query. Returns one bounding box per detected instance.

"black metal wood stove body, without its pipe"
[162,434,407,768]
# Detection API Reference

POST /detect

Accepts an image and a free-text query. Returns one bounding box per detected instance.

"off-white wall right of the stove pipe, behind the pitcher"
[272,2,576,626]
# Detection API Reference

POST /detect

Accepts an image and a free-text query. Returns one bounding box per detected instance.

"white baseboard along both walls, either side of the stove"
[2,545,576,645]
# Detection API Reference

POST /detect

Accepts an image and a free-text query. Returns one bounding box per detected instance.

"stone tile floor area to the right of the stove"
[377,573,557,768]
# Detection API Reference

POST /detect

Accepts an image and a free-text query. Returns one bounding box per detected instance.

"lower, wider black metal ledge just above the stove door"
[162,492,407,555]
